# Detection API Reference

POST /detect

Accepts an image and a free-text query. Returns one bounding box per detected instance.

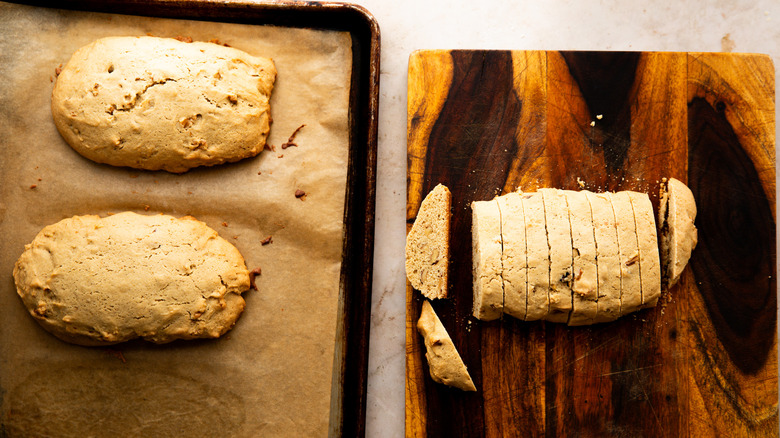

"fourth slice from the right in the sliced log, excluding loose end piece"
[564,190,598,325]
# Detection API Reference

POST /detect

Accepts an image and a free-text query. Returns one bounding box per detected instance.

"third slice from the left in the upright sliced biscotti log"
[520,192,550,321]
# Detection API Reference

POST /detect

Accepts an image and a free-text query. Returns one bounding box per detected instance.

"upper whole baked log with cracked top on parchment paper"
[51,36,276,173]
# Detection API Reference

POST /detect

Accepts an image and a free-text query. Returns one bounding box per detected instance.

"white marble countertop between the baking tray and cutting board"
[354,0,780,438]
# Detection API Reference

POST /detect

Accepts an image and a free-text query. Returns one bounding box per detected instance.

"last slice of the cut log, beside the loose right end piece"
[628,192,661,308]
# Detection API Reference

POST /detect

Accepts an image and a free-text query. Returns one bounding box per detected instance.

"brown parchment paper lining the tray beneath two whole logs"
[0,3,351,437]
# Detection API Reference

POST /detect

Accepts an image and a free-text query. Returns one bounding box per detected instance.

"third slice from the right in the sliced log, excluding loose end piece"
[585,191,620,322]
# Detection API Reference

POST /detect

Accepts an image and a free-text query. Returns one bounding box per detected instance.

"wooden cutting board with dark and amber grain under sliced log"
[406,51,778,437]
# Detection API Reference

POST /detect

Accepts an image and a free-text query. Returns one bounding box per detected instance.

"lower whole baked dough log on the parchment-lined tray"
[13,212,249,345]
